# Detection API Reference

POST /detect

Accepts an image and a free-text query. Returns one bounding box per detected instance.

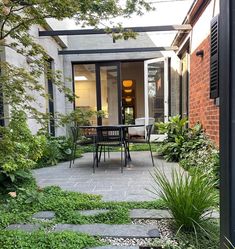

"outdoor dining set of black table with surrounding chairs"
[69,118,154,173]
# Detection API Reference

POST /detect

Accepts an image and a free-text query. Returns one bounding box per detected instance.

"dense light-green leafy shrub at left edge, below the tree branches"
[0,111,45,191]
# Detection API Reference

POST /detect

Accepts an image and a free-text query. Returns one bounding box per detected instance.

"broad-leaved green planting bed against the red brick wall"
[156,115,219,184]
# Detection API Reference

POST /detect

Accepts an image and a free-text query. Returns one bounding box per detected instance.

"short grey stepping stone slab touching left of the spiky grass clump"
[130,209,173,219]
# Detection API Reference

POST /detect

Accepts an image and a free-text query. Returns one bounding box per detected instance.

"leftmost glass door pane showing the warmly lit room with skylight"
[74,64,97,125]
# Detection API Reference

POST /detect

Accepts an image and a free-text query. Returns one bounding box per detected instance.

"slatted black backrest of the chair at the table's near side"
[96,126,124,143]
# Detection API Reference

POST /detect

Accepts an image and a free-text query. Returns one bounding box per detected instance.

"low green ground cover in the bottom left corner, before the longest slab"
[0,231,103,249]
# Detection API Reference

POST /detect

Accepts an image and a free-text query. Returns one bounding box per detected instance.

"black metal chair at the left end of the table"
[69,124,96,168]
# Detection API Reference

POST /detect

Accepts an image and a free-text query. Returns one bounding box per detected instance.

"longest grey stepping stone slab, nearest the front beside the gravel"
[54,224,160,238]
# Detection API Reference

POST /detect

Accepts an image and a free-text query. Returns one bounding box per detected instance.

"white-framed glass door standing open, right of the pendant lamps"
[144,58,169,134]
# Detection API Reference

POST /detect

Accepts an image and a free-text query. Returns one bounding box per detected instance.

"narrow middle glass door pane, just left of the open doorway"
[98,64,121,125]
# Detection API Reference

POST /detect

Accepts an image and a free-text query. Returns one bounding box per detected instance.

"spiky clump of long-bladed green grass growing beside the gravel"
[153,169,218,231]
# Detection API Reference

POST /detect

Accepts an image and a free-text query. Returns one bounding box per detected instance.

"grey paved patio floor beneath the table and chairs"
[33,151,179,201]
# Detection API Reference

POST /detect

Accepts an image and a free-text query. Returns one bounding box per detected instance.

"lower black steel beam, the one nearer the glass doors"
[58,46,178,55]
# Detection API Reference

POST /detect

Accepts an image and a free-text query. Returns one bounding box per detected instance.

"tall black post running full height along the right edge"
[219,0,235,249]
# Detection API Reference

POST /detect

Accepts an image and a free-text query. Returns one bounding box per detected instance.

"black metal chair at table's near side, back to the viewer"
[93,126,127,173]
